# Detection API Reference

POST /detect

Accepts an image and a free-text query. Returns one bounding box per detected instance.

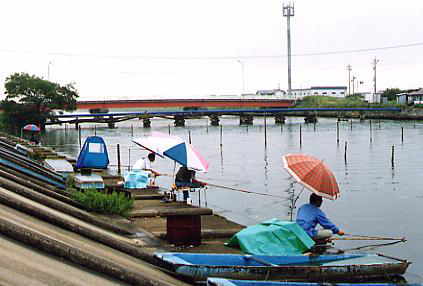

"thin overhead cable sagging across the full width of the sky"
[0,42,423,61]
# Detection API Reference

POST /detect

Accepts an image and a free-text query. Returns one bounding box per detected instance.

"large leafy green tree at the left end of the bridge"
[2,73,78,130]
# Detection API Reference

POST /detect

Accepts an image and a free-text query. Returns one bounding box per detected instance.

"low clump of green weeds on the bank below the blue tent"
[71,189,134,217]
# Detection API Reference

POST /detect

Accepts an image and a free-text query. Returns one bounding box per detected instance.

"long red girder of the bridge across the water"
[77,98,295,109]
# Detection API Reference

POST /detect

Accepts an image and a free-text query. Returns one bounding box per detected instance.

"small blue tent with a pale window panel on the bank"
[76,136,109,169]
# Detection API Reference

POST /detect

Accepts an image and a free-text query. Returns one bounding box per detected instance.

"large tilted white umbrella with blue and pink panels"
[132,132,209,172]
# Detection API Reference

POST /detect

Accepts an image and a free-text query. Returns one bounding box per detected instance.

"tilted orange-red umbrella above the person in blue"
[282,154,339,200]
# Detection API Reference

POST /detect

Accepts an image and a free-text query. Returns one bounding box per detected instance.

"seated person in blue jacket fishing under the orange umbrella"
[297,194,345,240]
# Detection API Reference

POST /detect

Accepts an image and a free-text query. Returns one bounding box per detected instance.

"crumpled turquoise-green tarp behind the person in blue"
[226,218,314,255]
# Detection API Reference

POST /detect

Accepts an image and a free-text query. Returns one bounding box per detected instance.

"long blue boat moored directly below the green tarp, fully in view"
[155,253,410,282]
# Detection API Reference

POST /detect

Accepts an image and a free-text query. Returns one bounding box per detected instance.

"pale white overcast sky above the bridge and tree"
[0,0,423,100]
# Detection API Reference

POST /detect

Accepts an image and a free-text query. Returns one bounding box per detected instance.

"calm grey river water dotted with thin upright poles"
[42,117,423,282]
